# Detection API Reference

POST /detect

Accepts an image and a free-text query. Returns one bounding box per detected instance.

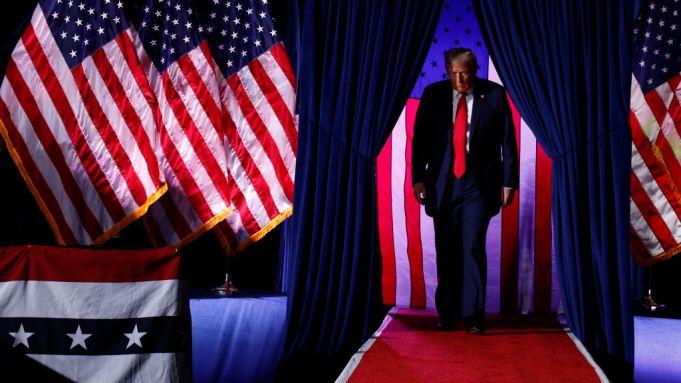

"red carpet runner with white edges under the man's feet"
[338,309,605,383]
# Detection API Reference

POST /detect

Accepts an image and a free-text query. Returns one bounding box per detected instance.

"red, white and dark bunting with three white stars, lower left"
[0,246,191,382]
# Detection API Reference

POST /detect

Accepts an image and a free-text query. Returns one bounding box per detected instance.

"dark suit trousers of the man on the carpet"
[433,176,491,324]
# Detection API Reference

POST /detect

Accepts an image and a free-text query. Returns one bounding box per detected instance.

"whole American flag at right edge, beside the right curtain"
[629,0,681,264]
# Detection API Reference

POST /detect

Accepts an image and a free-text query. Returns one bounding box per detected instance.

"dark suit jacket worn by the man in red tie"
[412,78,518,216]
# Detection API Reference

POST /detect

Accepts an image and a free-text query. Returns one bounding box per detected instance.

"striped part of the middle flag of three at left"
[138,41,231,247]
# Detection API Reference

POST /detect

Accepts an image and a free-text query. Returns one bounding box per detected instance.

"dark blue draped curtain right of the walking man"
[474,0,637,374]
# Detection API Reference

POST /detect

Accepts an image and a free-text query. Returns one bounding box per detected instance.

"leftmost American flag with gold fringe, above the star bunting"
[0,0,166,244]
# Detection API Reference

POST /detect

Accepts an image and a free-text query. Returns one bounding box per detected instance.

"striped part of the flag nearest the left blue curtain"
[216,43,298,252]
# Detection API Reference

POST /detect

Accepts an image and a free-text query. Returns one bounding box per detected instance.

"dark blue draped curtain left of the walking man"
[280,0,442,381]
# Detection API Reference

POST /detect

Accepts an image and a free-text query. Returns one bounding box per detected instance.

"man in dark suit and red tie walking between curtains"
[412,48,518,334]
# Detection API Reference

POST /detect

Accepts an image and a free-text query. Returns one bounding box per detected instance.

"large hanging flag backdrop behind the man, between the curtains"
[376,1,559,313]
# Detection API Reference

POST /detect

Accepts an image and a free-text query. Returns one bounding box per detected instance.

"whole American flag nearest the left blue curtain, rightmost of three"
[194,0,298,255]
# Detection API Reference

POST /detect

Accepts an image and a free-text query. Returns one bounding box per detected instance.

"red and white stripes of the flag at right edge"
[629,74,681,263]
